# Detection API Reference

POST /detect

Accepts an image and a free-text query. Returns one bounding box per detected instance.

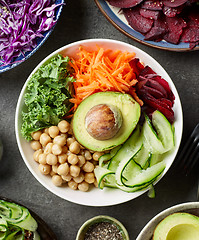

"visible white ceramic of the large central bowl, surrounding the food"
[15,39,183,206]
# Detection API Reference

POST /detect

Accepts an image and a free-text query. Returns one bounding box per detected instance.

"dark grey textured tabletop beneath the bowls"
[0,0,199,240]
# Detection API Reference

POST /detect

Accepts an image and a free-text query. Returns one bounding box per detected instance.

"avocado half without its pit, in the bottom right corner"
[153,212,199,240]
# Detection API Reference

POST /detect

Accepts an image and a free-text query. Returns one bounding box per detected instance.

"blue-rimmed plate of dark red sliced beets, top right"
[95,0,199,51]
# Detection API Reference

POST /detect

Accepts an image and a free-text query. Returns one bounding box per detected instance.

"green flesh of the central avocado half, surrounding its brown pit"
[72,92,141,152]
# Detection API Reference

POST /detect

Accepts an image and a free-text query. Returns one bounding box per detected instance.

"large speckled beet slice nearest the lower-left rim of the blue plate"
[123,7,153,33]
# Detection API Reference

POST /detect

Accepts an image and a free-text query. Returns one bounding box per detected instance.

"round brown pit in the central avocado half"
[85,104,122,140]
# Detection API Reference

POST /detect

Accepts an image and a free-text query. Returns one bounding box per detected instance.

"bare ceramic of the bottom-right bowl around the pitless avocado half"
[136,202,199,240]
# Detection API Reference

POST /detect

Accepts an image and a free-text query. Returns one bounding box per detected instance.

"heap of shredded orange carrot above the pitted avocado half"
[69,47,143,110]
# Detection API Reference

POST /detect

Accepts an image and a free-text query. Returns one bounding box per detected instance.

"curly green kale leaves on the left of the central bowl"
[22,54,75,140]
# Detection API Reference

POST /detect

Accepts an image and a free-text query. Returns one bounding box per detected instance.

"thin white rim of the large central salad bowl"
[15,38,183,206]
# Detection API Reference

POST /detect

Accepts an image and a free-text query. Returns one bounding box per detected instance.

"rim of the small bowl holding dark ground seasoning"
[76,215,129,240]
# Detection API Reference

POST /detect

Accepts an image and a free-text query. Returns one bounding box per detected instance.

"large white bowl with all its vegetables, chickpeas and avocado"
[15,39,182,206]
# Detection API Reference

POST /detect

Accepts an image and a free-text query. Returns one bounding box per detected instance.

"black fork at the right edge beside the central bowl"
[176,123,199,200]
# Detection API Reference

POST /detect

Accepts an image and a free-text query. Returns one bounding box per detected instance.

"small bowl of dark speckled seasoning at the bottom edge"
[76,215,129,240]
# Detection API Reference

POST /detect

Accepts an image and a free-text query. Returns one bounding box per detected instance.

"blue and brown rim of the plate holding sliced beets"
[95,0,199,52]
